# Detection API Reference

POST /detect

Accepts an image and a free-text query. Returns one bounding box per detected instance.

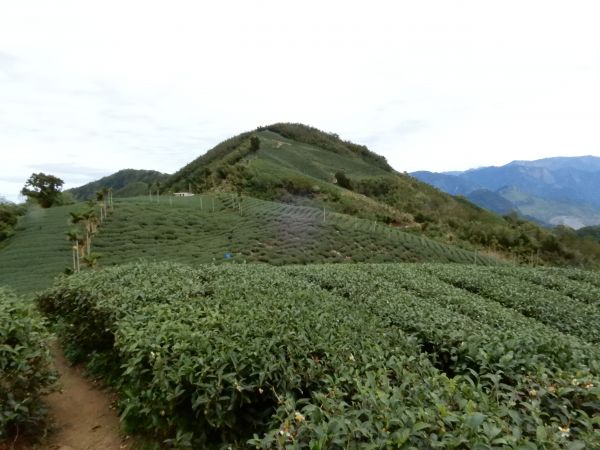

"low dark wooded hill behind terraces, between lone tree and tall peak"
[66,169,169,200]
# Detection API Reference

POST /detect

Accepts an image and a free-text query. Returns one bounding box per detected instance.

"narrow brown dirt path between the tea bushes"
[42,345,131,450]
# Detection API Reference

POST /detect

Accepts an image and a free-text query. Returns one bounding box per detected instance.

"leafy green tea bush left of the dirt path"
[0,287,56,440]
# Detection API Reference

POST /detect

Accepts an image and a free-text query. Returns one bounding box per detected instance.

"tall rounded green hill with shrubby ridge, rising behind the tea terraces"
[163,124,600,264]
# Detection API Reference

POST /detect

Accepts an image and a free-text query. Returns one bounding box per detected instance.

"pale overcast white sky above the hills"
[0,0,600,201]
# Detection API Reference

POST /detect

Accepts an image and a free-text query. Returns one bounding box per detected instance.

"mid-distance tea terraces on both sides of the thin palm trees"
[0,194,498,293]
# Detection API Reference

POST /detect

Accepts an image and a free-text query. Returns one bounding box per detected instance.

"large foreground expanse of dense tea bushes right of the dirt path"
[37,262,600,449]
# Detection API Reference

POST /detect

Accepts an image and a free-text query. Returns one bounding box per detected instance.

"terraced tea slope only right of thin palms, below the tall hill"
[94,194,496,266]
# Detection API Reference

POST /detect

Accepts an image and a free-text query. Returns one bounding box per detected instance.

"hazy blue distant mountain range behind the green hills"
[411,156,600,229]
